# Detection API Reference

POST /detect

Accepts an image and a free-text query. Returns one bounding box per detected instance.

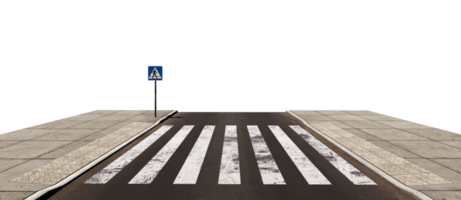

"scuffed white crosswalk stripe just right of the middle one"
[247,125,286,185]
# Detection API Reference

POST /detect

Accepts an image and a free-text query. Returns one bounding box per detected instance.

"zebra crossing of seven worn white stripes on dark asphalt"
[84,125,376,185]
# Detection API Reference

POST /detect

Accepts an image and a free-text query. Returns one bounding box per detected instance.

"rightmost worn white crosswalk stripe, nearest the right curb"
[290,125,376,185]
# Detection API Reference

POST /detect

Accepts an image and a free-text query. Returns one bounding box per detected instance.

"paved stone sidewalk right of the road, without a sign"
[286,109,461,200]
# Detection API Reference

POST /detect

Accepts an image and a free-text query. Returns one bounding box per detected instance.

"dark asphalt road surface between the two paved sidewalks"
[45,111,411,200]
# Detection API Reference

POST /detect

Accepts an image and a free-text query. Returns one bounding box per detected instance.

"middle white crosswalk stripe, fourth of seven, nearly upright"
[218,125,240,185]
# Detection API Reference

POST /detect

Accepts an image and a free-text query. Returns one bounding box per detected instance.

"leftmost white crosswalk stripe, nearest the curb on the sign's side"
[85,125,173,184]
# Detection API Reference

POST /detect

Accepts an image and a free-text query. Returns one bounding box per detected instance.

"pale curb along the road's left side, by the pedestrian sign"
[24,109,179,200]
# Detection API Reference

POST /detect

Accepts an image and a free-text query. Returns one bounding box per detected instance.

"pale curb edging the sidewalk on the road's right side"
[284,109,433,200]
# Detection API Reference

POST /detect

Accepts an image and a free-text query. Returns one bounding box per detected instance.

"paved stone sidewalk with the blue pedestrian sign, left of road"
[0,109,177,200]
